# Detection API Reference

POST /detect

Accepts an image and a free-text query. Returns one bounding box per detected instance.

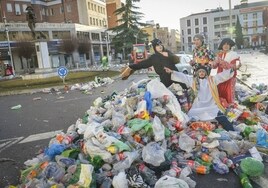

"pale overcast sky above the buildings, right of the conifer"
[136,0,268,29]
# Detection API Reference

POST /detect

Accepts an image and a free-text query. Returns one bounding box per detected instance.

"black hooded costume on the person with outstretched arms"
[129,39,187,89]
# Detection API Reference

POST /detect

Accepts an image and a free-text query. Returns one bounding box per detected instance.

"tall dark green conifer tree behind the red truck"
[109,0,148,57]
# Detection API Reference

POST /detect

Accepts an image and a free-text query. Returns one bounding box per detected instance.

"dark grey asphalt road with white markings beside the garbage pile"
[0,74,264,188]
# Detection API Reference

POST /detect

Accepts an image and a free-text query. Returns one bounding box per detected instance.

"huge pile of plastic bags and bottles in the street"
[15,79,268,188]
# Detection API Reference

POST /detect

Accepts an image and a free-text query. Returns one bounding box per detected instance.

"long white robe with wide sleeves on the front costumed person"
[171,69,234,121]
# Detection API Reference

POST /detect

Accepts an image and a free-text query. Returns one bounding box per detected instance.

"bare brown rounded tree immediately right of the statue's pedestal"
[60,36,78,67]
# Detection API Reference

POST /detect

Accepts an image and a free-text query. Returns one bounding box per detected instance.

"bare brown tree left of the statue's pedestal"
[16,34,35,72]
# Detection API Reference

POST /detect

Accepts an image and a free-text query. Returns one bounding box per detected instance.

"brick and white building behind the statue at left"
[0,0,121,72]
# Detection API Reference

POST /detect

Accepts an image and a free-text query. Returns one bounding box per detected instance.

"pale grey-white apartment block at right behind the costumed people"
[180,1,268,53]
